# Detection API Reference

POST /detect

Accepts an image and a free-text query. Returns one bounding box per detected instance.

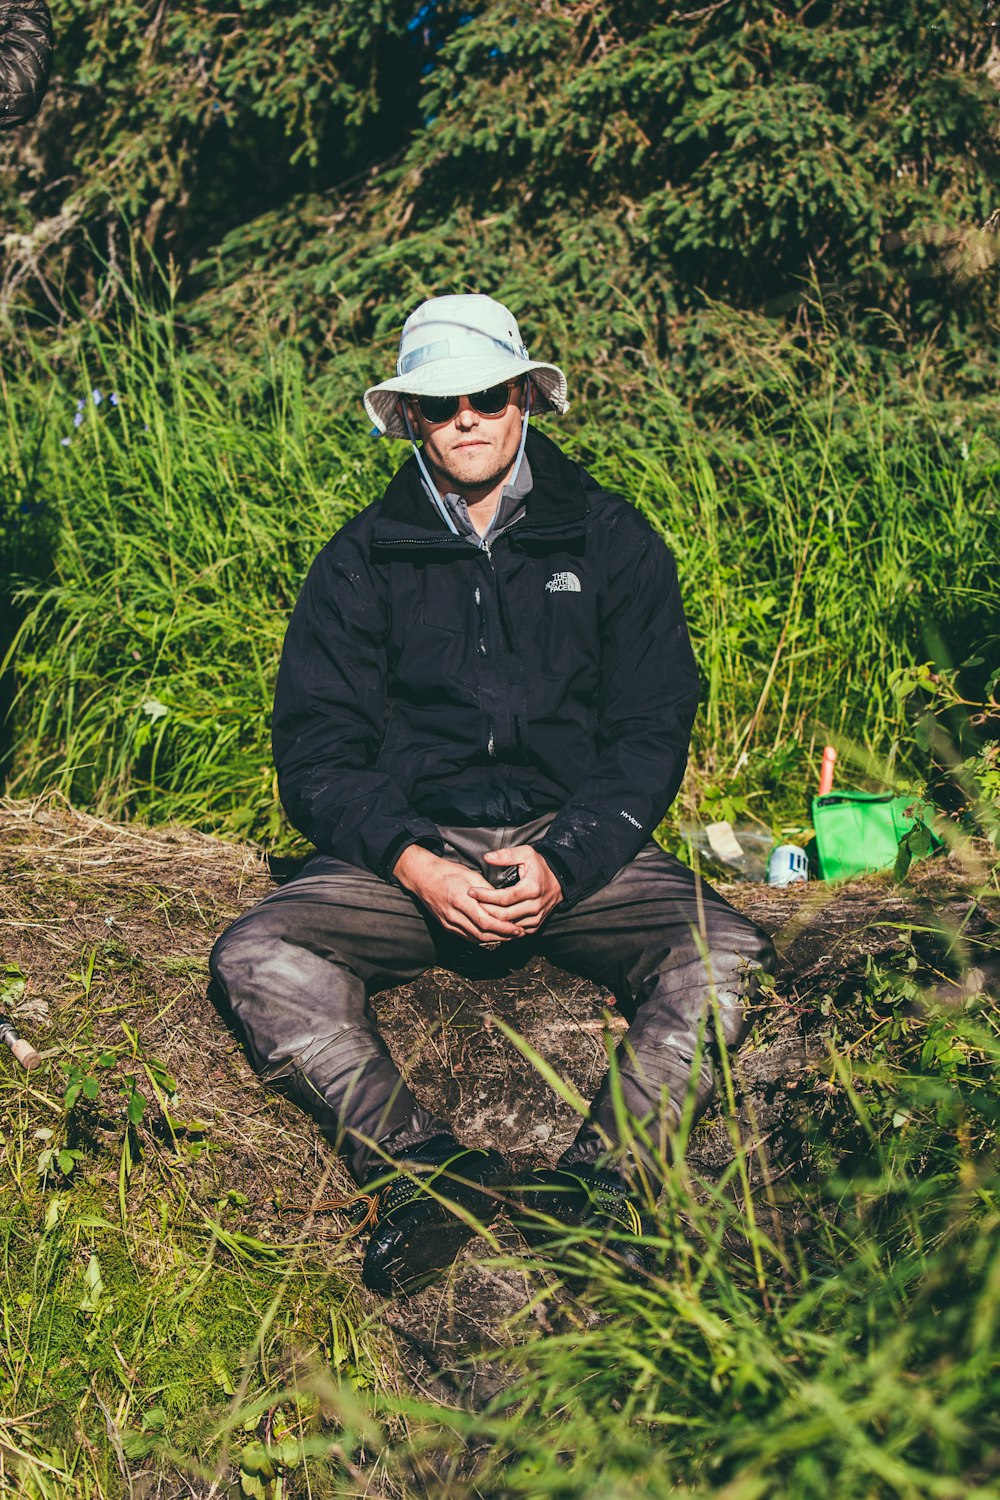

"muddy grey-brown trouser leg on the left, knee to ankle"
[211,855,450,1182]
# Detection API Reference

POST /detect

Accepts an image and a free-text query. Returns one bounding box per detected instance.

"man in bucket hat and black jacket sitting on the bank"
[211,296,771,1295]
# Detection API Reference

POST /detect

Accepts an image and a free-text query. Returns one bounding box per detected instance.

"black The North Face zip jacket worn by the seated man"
[273,432,697,906]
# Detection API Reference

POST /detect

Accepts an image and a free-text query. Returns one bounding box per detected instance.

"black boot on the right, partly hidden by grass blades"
[511,1166,651,1280]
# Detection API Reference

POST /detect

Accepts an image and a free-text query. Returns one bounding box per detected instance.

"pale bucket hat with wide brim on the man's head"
[364,293,570,438]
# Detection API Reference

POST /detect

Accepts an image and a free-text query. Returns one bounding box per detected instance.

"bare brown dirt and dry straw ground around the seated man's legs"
[0,798,997,1401]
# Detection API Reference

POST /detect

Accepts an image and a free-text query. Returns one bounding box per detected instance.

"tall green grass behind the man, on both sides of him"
[0,301,1000,842]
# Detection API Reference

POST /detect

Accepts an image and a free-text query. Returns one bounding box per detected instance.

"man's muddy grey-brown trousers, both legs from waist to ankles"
[211,819,772,1182]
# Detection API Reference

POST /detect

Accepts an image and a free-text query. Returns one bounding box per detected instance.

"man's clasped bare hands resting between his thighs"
[393,845,562,944]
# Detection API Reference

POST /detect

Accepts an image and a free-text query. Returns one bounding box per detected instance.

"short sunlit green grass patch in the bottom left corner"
[0,1068,394,1500]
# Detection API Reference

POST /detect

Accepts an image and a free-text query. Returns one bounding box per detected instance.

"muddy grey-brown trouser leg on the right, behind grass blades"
[538,843,774,1191]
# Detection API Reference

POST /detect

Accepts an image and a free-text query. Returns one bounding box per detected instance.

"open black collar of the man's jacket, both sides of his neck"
[375,428,597,542]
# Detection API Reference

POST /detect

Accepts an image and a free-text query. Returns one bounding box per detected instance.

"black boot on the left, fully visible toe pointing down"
[361,1136,510,1298]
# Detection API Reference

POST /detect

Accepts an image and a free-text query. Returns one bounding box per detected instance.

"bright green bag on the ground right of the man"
[813,792,940,881]
